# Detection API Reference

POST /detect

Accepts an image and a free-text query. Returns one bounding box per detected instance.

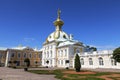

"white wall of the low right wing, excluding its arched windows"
[80,51,120,69]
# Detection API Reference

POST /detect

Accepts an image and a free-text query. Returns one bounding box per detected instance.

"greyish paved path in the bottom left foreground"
[0,67,58,80]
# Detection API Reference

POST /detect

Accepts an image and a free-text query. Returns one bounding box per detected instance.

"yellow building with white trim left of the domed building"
[0,46,42,66]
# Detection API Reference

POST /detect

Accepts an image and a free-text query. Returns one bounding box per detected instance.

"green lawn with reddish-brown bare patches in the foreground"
[28,69,118,80]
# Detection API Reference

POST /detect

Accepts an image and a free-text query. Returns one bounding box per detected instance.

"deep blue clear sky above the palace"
[0,0,120,50]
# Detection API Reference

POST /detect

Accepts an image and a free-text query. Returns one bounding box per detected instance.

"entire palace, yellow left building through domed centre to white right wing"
[0,10,120,69]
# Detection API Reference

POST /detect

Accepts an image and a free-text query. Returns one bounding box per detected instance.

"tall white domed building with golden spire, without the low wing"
[42,10,84,67]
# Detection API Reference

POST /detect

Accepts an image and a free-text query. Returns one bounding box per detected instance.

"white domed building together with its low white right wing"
[41,10,120,69]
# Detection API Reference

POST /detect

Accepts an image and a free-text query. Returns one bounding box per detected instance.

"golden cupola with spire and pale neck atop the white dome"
[54,9,64,31]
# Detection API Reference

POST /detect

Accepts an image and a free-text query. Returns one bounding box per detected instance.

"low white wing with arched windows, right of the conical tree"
[77,50,120,69]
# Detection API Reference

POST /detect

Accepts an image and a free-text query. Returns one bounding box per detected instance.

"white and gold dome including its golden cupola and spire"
[46,9,69,43]
